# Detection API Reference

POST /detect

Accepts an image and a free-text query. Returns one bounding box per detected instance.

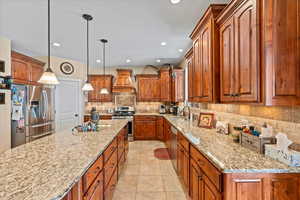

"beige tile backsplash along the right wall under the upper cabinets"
[191,103,300,143]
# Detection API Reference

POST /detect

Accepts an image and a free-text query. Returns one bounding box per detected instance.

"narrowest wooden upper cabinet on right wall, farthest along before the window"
[185,48,194,102]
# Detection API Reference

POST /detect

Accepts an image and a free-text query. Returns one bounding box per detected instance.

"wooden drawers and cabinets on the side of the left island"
[63,126,128,200]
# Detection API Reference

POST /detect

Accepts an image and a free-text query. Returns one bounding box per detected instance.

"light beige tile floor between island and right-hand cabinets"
[113,141,187,200]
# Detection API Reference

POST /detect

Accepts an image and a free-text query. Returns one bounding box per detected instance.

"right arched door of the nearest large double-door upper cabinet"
[234,0,260,102]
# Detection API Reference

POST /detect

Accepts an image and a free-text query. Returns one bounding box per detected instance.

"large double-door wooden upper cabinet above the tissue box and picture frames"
[218,0,261,103]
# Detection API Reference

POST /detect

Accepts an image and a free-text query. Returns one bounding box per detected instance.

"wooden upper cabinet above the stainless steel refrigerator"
[11,51,45,84]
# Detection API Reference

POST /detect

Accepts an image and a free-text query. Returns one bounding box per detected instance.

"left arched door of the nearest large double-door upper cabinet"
[220,19,235,102]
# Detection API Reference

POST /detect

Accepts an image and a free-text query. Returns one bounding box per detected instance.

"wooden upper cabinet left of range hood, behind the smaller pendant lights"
[88,75,113,102]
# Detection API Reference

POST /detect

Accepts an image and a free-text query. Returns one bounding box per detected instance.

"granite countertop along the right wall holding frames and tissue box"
[162,114,300,173]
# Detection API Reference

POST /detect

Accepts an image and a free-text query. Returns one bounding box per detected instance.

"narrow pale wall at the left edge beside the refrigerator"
[0,37,11,153]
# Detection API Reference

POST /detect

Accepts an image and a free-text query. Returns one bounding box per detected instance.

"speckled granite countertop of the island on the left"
[0,120,128,200]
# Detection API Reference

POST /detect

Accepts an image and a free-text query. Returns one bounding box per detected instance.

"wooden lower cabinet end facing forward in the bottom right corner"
[224,173,300,200]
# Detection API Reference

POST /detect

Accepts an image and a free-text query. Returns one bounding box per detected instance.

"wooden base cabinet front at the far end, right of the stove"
[134,120,156,140]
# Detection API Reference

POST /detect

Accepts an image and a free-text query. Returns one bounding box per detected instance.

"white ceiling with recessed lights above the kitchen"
[0,0,228,66]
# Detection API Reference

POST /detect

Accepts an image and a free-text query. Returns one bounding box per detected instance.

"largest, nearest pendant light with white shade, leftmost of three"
[38,0,59,85]
